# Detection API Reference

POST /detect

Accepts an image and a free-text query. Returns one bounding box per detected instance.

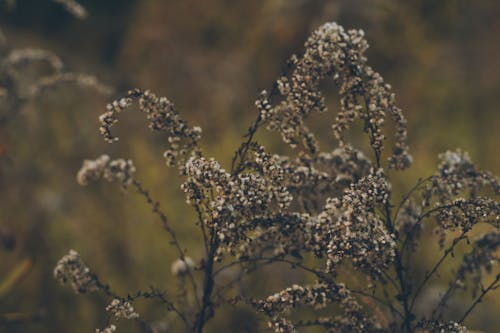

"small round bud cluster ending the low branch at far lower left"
[54,250,100,294]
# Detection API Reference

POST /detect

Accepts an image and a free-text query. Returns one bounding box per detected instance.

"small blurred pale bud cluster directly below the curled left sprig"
[76,155,135,188]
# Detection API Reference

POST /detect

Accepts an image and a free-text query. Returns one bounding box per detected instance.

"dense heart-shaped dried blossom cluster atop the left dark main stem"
[182,146,292,253]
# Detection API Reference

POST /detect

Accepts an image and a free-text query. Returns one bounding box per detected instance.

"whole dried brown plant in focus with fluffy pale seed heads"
[55,23,500,332]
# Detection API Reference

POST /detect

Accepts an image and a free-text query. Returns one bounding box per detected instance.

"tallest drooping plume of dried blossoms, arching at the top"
[256,23,411,169]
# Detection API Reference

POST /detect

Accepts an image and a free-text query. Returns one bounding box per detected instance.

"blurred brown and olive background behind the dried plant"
[0,0,500,332]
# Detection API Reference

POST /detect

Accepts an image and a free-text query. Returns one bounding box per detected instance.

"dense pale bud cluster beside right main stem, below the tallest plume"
[322,169,396,278]
